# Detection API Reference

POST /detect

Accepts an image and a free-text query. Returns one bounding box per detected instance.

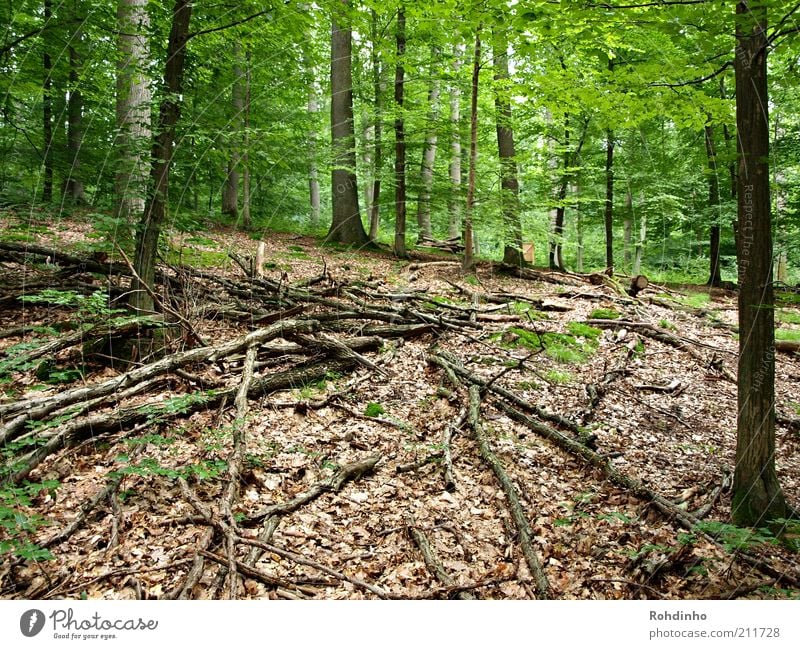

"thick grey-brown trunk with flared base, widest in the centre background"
[326,0,368,245]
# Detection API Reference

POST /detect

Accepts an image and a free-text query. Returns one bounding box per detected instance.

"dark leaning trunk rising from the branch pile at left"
[130,0,192,311]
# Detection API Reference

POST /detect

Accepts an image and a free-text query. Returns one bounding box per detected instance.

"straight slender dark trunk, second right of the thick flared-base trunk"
[394,5,407,257]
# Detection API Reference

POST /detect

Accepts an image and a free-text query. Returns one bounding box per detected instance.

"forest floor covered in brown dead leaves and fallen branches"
[0,214,800,599]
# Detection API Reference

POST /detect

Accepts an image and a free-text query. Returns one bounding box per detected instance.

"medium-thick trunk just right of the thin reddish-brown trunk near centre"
[492,29,522,266]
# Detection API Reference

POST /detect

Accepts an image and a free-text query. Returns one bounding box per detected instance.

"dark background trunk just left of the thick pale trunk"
[64,0,86,204]
